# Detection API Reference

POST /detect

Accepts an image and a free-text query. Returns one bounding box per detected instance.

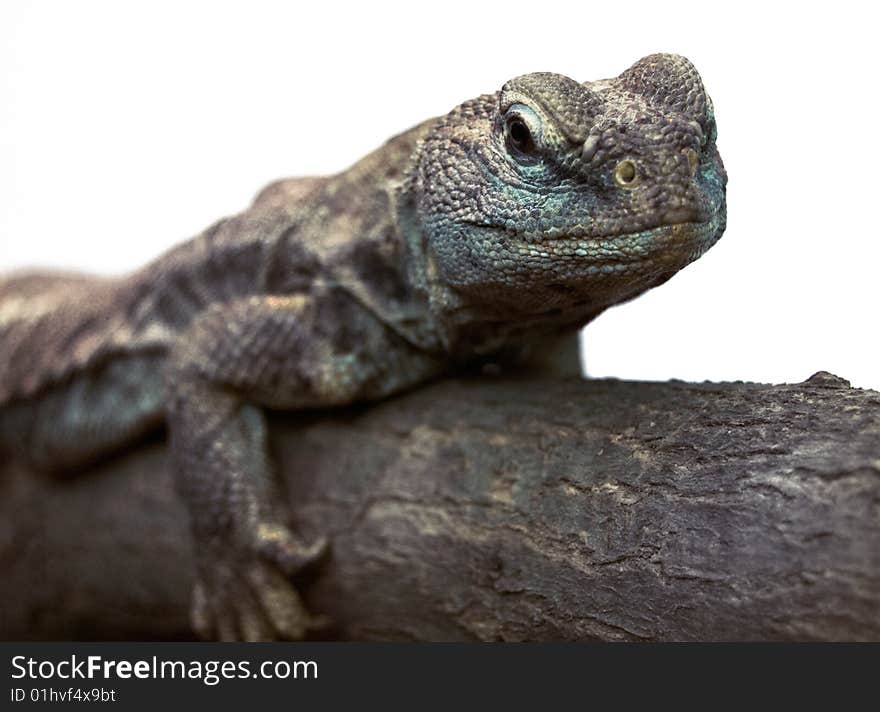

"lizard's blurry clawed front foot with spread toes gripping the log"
[191,525,329,641]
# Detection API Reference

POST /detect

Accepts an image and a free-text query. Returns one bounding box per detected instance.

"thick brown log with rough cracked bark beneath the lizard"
[0,373,880,640]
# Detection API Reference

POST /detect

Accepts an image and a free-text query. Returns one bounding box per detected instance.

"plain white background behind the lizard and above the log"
[0,0,880,388]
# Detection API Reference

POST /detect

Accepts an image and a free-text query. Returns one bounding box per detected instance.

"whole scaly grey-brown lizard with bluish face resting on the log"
[0,54,727,640]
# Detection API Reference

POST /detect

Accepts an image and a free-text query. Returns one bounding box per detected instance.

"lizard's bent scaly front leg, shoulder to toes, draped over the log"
[167,293,432,639]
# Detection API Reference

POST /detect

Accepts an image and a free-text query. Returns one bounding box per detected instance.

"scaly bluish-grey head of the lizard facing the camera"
[415,54,727,322]
